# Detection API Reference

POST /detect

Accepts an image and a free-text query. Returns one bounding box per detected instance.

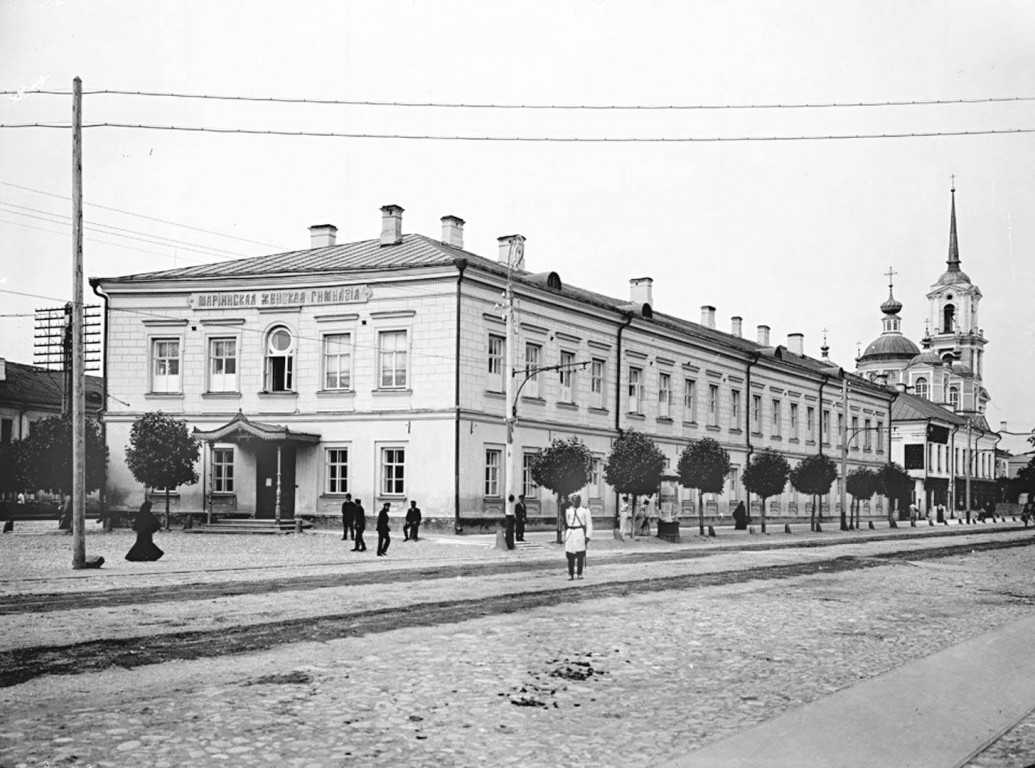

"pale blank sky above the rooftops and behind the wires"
[0,0,1035,432]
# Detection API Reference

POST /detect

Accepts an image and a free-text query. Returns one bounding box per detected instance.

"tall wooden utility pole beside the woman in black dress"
[71,78,86,569]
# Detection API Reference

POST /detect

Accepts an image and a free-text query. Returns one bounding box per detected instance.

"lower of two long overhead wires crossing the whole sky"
[0,122,1035,144]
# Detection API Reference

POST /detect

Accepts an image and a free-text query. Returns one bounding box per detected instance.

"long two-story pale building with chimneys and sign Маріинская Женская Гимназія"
[91,205,894,527]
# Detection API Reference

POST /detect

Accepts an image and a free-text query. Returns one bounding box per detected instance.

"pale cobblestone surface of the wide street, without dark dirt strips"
[6,519,1035,768]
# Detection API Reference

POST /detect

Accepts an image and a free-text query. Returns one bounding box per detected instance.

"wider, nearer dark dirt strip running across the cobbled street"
[0,538,1035,687]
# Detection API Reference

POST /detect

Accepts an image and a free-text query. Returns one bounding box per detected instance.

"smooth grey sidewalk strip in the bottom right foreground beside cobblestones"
[668,617,1035,768]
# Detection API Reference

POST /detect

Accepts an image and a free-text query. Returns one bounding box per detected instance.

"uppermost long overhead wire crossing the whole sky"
[6,88,1035,112]
